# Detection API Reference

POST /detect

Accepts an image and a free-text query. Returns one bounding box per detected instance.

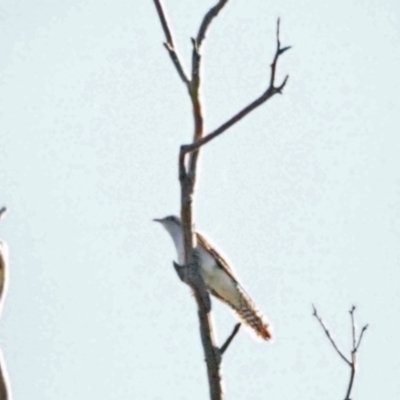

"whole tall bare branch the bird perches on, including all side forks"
[154,0,289,400]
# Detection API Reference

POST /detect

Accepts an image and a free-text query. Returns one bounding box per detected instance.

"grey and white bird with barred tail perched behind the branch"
[154,215,271,340]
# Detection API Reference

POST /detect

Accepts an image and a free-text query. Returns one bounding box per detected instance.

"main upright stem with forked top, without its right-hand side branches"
[154,0,227,400]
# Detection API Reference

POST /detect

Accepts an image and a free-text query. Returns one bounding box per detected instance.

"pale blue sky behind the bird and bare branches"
[0,0,400,400]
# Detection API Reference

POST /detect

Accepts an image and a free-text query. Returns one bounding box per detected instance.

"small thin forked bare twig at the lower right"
[313,305,368,400]
